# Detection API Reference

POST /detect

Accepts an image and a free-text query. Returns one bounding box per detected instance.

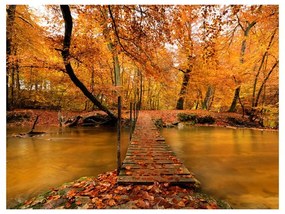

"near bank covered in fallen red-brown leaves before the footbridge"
[13,171,231,209]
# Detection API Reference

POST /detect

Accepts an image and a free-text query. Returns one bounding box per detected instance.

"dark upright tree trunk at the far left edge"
[6,5,16,110]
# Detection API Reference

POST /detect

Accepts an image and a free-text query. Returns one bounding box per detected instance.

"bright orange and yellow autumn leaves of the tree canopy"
[8,5,279,113]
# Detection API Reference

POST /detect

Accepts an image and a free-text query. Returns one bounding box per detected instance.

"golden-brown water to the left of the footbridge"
[7,127,128,207]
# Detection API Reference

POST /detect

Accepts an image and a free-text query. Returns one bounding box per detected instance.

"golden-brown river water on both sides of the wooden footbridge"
[6,127,278,208]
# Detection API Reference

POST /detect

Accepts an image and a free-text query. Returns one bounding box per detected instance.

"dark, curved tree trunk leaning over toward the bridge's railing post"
[60,5,117,120]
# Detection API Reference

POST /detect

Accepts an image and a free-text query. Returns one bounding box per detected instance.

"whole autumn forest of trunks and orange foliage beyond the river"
[6,5,279,126]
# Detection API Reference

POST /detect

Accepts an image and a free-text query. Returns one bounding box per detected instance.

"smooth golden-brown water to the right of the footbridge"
[162,127,278,208]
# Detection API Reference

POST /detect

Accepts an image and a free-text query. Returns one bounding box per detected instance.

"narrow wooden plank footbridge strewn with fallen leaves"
[118,114,200,186]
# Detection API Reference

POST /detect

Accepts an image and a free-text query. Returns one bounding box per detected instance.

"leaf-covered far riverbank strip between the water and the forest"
[6,109,279,132]
